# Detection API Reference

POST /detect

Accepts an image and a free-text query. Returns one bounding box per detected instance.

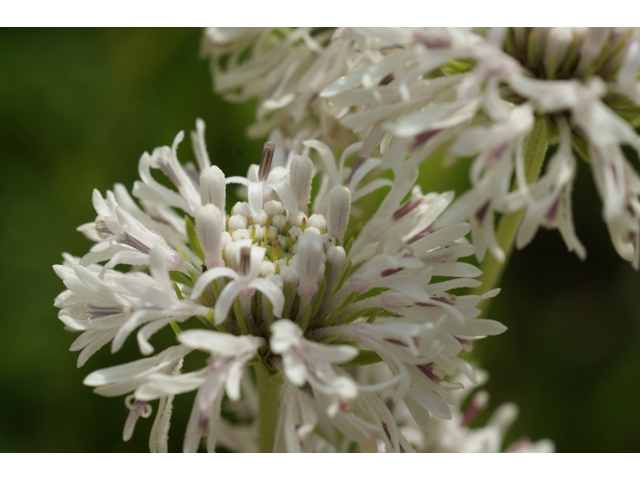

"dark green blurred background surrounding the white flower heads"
[0,29,640,452]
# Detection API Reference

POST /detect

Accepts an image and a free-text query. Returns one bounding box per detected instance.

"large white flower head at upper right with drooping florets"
[320,28,640,266]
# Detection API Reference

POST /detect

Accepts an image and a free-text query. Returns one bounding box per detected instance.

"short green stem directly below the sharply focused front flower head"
[254,364,280,453]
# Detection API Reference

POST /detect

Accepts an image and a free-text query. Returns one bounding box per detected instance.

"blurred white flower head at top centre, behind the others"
[203,28,351,144]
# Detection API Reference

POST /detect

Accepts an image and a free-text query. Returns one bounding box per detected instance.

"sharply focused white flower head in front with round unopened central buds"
[54,121,516,452]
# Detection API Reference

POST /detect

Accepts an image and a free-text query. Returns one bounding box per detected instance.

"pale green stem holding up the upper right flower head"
[472,117,548,304]
